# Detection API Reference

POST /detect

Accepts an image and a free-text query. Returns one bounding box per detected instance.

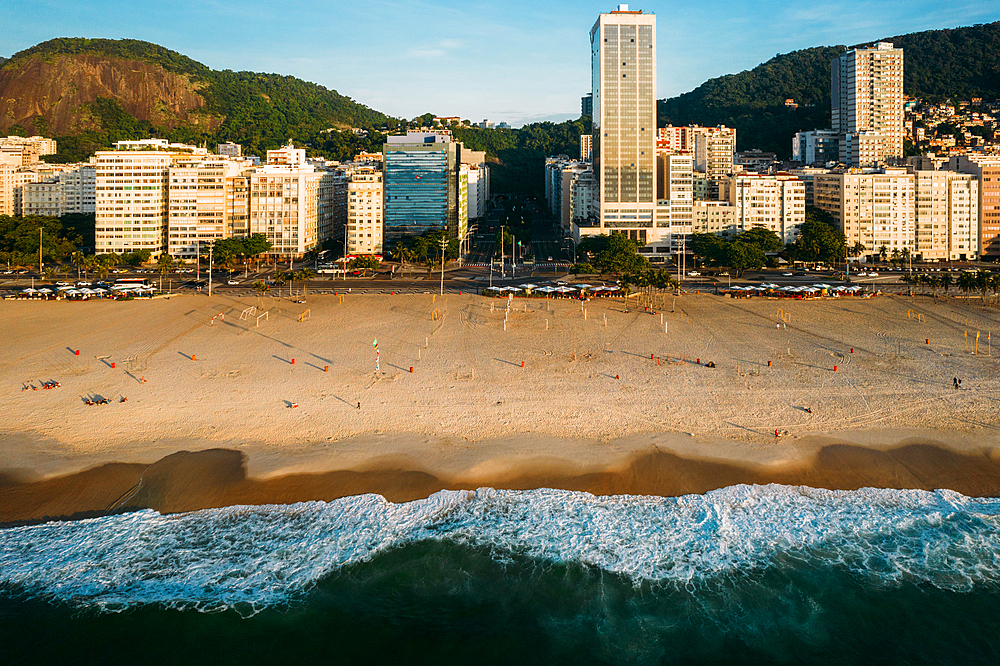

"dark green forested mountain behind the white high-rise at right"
[658,22,1000,158]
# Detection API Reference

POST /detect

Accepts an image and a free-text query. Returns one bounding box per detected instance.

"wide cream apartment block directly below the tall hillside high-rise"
[815,169,916,256]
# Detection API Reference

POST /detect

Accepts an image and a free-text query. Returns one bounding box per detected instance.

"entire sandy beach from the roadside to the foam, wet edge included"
[0,294,1000,522]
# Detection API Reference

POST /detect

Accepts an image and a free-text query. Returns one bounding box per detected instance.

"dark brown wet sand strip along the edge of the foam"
[0,438,1000,525]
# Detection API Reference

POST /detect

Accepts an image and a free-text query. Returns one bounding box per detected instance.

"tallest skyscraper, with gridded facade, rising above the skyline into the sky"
[585,5,656,244]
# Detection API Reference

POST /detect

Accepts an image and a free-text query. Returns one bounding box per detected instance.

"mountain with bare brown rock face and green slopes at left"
[0,38,391,156]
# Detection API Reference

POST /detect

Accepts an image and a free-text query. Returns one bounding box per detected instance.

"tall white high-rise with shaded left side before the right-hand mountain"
[830,42,906,167]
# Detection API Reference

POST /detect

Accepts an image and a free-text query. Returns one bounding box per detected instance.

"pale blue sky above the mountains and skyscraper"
[0,0,1000,125]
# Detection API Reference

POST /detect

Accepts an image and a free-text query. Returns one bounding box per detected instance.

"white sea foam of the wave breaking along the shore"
[0,485,1000,612]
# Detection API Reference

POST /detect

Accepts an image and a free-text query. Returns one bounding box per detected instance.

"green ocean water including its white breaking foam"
[0,485,1000,664]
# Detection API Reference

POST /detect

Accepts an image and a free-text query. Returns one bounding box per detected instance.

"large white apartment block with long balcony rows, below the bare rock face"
[94,139,207,258]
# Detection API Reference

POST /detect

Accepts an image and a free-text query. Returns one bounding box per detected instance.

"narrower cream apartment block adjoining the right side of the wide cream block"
[913,171,979,261]
